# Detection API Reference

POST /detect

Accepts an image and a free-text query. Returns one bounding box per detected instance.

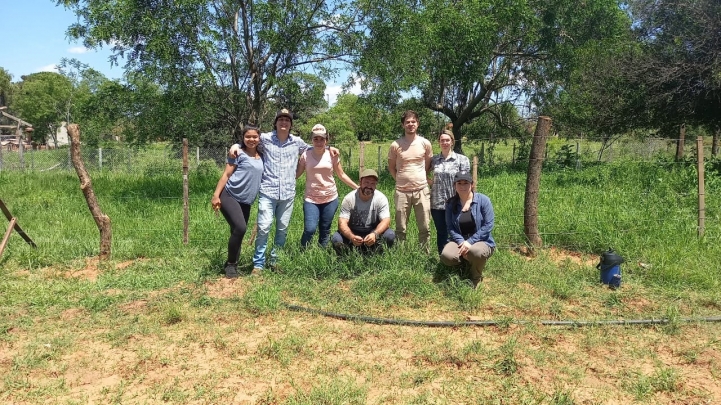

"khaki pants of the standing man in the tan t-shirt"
[393,187,431,249]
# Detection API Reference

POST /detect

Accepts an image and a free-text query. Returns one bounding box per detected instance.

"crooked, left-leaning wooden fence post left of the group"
[68,124,113,260]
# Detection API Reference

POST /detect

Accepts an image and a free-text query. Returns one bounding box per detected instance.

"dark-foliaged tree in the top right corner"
[628,0,721,133]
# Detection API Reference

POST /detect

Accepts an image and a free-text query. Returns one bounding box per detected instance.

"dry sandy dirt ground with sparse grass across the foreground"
[0,255,721,404]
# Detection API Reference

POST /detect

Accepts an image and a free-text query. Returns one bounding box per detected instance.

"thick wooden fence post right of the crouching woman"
[523,116,551,247]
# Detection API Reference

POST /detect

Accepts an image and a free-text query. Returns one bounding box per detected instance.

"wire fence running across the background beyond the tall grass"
[0,138,711,175]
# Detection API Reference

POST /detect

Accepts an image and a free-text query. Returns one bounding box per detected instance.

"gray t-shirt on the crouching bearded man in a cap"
[340,190,391,235]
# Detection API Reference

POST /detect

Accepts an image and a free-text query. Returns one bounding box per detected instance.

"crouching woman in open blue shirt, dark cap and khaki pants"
[441,171,496,288]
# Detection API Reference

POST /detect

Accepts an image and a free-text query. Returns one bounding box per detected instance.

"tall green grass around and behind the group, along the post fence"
[0,153,721,320]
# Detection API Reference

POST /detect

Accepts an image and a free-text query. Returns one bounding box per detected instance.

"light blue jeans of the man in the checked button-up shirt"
[253,194,293,269]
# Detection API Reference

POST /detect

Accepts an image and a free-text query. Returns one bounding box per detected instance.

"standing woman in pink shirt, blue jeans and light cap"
[295,124,358,247]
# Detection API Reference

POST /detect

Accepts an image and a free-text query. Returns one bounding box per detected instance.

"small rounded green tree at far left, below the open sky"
[13,72,73,146]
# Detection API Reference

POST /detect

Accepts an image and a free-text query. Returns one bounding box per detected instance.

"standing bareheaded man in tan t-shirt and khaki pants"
[388,110,433,250]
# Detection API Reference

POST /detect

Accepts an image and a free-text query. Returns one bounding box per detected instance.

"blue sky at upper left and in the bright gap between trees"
[0,0,360,105]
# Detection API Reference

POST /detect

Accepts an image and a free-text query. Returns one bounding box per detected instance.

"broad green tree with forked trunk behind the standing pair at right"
[357,0,628,150]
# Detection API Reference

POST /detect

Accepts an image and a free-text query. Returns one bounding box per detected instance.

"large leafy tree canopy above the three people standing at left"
[57,0,360,137]
